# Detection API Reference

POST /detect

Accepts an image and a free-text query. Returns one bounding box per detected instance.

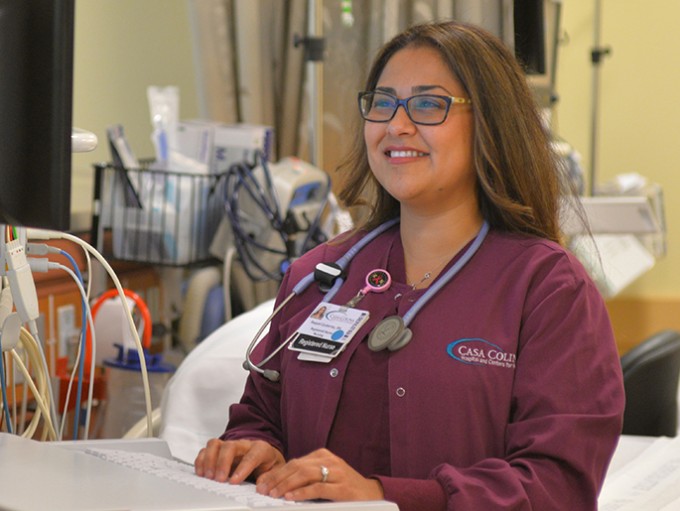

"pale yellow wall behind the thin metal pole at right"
[557,0,680,349]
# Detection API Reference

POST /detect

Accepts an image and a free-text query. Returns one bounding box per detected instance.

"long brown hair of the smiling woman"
[338,21,562,242]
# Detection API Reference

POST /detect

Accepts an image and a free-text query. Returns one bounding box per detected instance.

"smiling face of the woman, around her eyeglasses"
[364,47,478,217]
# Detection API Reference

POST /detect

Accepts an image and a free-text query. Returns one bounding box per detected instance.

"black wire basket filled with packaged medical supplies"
[92,162,224,266]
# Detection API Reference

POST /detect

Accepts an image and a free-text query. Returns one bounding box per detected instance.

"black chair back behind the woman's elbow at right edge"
[621,330,680,437]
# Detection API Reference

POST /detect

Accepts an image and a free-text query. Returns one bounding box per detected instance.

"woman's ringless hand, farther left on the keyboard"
[194,438,285,484]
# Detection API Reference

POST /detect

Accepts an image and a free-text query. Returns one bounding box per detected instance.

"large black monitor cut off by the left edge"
[0,0,75,230]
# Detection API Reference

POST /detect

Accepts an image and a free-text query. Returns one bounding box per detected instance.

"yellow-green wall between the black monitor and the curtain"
[71,0,198,229]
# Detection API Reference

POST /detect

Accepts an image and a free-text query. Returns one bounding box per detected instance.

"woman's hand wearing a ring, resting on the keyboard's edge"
[257,449,384,500]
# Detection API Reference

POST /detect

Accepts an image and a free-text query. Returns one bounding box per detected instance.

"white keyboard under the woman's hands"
[85,448,303,508]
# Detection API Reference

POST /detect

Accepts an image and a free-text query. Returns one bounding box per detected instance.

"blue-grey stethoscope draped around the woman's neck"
[243,218,489,382]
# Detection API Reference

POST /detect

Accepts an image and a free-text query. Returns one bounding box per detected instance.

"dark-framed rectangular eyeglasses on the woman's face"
[359,91,472,126]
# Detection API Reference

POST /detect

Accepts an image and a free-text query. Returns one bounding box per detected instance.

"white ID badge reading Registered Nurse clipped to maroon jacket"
[288,302,369,362]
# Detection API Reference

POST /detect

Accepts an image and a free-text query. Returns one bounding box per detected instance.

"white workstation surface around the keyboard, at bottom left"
[0,433,397,511]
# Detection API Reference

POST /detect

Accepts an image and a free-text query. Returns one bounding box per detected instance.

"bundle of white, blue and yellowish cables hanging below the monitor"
[0,226,153,440]
